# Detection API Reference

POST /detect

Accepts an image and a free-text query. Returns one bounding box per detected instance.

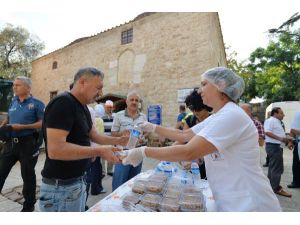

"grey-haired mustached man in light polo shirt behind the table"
[111,91,146,191]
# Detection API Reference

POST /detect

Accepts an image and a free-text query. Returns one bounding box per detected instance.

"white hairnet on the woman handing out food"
[202,67,245,102]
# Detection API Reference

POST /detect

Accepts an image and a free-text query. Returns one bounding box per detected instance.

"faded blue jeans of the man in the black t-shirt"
[39,179,86,212]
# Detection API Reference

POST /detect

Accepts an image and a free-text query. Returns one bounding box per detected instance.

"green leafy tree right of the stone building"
[247,13,300,103]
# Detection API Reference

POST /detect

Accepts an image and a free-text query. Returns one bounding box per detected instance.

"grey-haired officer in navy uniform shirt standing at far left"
[0,76,45,212]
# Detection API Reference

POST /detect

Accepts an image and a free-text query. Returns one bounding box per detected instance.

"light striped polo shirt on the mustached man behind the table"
[111,109,147,132]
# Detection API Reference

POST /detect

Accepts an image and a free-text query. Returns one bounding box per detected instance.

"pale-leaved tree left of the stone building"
[0,24,44,79]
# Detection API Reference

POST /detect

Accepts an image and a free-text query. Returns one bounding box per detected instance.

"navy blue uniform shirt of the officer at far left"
[8,96,45,137]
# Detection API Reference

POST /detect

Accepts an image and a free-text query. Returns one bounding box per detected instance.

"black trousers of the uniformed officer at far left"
[0,136,38,208]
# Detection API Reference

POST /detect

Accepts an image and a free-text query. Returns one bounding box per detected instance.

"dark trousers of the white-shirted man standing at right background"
[266,143,283,191]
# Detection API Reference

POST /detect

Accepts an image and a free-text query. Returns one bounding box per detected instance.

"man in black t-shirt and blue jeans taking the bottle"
[39,68,129,212]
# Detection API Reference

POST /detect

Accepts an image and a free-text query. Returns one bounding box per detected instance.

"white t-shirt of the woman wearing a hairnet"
[192,102,281,212]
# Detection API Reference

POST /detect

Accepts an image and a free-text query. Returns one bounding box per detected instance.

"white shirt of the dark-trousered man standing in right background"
[264,116,285,144]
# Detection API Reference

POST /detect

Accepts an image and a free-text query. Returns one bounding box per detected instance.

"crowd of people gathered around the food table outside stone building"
[0,67,300,212]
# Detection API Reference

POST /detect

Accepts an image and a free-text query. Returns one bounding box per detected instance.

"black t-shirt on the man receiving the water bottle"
[42,93,92,179]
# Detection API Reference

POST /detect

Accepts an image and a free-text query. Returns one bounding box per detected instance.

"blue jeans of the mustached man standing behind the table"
[112,162,143,191]
